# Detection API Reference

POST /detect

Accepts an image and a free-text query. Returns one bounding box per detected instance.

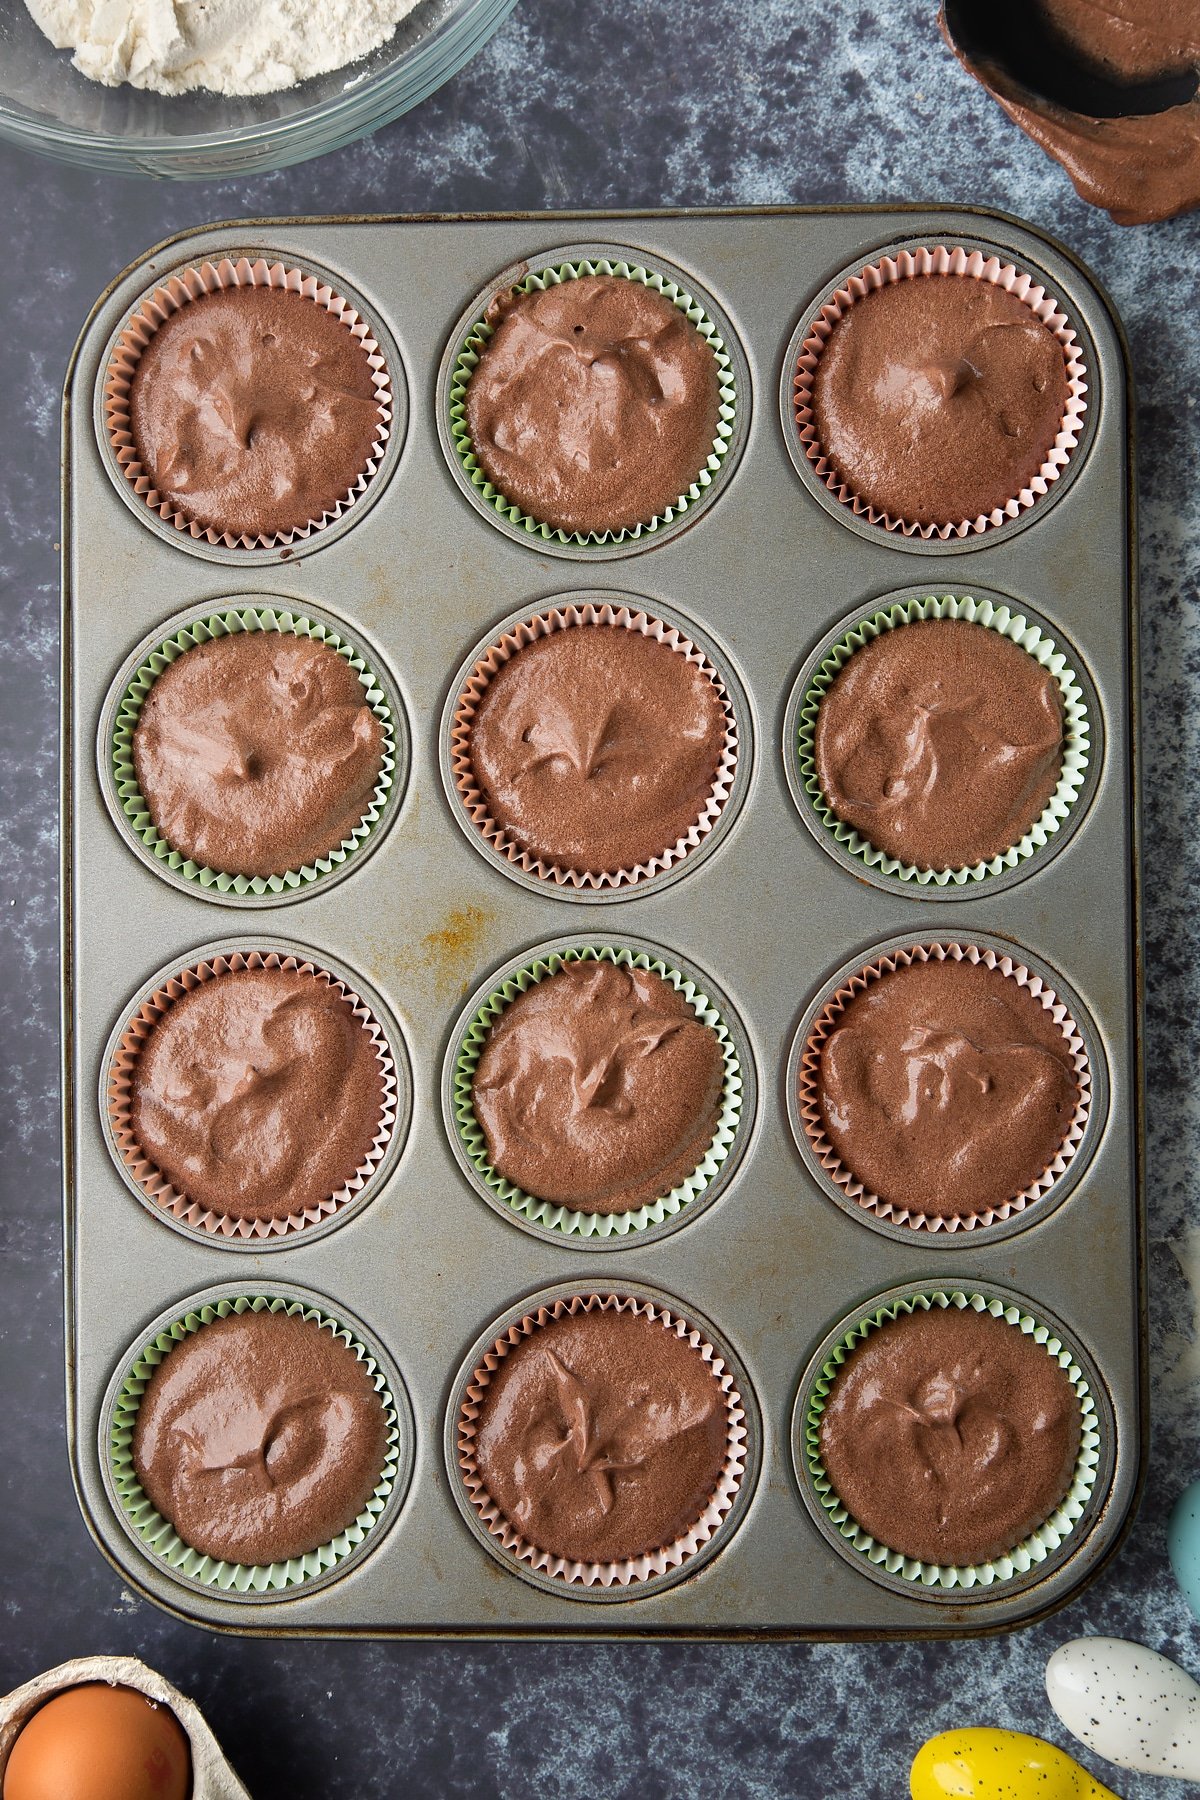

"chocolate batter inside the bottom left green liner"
[133,1312,387,1564]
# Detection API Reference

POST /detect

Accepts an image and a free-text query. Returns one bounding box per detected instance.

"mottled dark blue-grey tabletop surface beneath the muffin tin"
[0,0,1200,1800]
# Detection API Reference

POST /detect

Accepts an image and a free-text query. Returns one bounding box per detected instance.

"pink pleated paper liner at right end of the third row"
[797,943,1092,1231]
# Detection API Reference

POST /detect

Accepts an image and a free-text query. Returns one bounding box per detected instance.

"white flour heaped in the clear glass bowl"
[25,0,426,94]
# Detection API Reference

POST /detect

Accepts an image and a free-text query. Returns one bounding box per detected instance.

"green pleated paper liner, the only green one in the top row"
[448,257,738,545]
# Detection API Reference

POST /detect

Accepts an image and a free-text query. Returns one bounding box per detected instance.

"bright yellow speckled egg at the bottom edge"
[910,1724,1119,1800]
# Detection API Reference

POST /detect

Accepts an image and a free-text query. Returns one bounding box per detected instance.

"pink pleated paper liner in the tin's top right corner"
[793,245,1088,538]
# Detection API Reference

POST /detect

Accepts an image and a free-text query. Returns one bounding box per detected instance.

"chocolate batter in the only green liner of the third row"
[471,961,725,1213]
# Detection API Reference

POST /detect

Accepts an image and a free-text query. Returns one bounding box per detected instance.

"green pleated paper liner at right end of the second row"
[795,594,1092,887]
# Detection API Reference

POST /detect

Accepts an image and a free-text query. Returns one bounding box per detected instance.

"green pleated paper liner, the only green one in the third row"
[452,943,743,1238]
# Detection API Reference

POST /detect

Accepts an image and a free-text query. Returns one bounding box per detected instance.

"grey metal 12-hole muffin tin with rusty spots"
[63,207,1146,1638]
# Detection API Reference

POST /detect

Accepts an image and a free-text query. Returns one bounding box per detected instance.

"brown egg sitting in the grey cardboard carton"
[4,1681,193,1800]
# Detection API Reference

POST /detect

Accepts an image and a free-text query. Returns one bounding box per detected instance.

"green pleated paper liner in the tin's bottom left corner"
[108,1294,401,1597]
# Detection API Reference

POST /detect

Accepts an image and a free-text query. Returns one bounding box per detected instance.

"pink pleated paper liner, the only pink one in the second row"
[450,601,739,889]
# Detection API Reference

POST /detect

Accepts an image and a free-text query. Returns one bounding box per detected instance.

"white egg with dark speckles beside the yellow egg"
[1045,1638,1200,1782]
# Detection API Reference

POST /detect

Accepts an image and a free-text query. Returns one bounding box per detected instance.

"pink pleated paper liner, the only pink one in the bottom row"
[457,1294,748,1588]
